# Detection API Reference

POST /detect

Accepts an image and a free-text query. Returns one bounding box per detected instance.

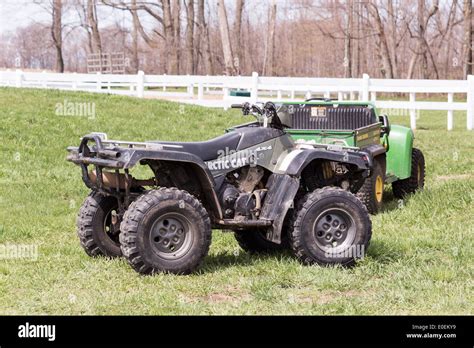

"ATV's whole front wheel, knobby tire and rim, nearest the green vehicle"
[290,187,372,266]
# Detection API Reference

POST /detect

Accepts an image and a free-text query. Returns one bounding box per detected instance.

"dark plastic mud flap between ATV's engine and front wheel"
[260,174,300,244]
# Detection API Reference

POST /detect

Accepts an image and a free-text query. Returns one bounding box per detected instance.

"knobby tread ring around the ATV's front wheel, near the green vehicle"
[289,186,372,266]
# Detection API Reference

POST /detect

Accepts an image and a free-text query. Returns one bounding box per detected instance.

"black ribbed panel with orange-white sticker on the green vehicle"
[291,105,377,130]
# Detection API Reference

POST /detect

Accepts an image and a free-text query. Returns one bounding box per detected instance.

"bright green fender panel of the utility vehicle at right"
[387,125,414,180]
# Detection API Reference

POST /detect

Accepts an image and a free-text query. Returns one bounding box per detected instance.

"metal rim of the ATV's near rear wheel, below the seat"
[150,213,193,259]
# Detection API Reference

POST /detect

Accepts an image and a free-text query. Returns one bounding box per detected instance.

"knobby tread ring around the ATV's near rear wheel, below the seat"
[120,187,211,274]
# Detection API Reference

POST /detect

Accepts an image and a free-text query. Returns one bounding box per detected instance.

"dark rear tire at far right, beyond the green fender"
[392,148,425,198]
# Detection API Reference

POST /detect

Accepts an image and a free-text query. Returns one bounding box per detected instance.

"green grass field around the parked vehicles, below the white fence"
[0,88,474,314]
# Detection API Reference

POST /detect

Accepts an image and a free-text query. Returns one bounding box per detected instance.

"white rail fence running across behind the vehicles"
[0,70,474,130]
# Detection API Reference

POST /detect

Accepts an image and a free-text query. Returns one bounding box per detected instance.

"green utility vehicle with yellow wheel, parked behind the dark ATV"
[280,98,425,214]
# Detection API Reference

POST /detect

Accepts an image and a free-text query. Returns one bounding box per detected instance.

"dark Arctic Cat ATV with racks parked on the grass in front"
[68,102,378,274]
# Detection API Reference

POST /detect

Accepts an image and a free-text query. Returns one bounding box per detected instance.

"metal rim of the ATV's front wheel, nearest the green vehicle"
[313,208,356,253]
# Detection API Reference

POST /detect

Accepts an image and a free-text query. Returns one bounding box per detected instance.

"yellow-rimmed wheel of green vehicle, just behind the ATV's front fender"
[356,155,386,215]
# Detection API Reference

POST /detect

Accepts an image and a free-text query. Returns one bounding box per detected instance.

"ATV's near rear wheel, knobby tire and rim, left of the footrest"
[120,188,211,274]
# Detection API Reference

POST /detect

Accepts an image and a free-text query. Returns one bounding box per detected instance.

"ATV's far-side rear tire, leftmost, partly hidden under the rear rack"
[77,191,122,257]
